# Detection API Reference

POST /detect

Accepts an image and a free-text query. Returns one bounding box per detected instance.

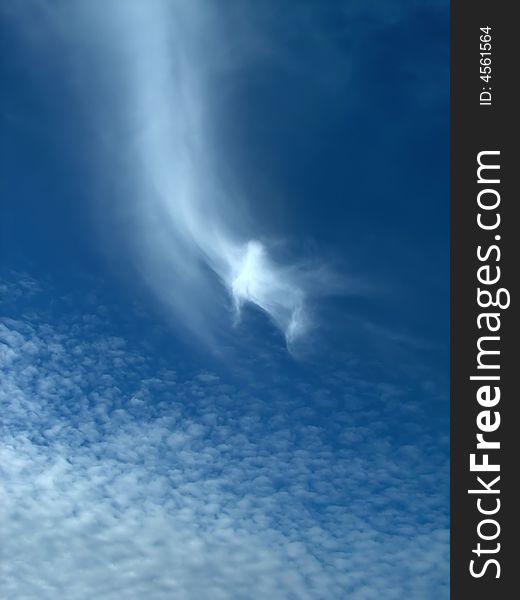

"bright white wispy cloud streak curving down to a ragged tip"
[115,2,338,345]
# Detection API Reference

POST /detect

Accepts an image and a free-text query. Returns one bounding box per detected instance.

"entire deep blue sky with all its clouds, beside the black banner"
[0,0,449,600]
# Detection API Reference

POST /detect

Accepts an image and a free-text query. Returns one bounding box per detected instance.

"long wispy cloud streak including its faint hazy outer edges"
[8,0,340,345]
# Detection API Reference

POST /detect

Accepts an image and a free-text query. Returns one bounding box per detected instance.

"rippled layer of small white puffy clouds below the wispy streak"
[0,278,448,600]
